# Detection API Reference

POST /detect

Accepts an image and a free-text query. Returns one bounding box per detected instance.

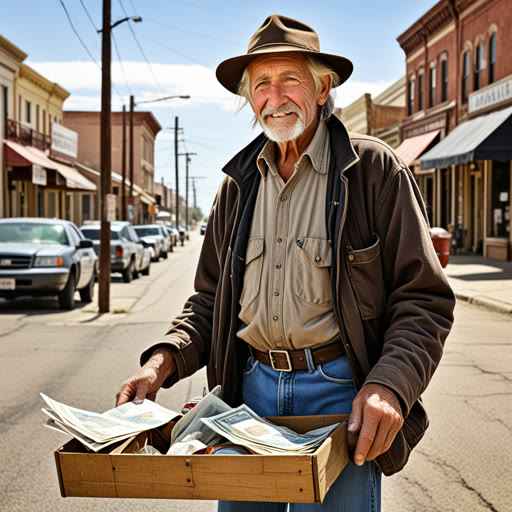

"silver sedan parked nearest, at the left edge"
[0,217,98,309]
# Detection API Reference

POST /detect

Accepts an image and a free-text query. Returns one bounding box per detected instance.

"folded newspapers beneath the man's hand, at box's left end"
[41,393,181,452]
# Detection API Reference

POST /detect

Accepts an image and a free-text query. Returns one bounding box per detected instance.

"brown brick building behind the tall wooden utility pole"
[64,111,162,224]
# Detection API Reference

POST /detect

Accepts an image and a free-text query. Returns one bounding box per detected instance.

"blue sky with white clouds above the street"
[0,0,436,214]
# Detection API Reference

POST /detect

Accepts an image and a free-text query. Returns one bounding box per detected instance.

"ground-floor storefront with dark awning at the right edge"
[420,107,512,260]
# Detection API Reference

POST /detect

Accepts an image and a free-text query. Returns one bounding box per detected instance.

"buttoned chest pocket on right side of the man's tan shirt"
[295,238,332,306]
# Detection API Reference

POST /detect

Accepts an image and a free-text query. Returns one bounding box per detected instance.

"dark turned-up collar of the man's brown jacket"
[222,115,359,186]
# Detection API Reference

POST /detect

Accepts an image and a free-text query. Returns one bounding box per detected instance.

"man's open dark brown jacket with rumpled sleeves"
[141,117,455,475]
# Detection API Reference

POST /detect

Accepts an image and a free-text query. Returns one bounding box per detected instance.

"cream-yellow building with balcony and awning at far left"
[0,38,96,222]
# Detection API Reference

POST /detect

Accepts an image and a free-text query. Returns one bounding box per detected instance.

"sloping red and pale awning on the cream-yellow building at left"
[4,140,97,191]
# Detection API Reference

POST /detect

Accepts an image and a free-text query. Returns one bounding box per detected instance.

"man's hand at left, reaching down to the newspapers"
[116,348,176,407]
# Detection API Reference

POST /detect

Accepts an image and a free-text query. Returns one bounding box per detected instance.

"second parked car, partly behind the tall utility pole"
[80,221,151,283]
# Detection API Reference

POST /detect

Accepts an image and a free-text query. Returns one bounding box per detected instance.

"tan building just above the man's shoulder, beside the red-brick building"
[334,77,405,148]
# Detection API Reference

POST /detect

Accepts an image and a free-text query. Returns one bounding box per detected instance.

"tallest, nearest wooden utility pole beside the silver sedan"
[98,0,112,313]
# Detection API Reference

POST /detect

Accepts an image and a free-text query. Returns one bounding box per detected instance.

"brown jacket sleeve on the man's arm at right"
[365,164,455,416]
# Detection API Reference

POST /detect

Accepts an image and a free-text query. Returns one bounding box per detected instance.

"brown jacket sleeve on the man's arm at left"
[140,181,226,388]
